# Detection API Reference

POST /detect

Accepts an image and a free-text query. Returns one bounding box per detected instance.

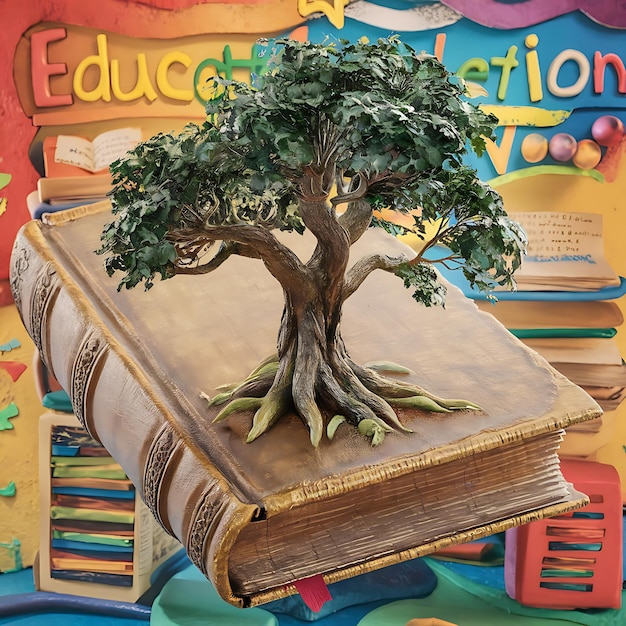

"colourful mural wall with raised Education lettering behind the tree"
[0,0,626,570]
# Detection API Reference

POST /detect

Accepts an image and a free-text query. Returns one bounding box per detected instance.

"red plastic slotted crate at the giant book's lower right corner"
[504,461,623,609]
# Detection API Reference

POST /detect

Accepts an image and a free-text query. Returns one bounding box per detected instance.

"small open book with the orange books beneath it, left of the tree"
[37,127,142,206]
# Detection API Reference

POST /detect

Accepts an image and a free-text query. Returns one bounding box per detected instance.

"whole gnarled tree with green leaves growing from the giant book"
[99,38,525,446]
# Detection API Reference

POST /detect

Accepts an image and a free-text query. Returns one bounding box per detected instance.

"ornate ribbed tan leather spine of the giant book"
[10,222,258,606]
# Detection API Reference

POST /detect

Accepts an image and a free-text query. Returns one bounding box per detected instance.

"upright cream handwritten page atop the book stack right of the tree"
[510,211,619,290]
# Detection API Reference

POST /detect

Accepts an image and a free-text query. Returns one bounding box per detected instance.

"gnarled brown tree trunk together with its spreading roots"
[211,193,478,446]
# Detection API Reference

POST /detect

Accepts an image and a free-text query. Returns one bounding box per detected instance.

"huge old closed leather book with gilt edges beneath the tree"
[11,203,601,606]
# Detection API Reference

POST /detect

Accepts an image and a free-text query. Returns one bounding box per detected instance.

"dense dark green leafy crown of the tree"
[103,38,524,304]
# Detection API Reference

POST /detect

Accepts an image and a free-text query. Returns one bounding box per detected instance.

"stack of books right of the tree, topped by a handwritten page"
[432,212,626,448]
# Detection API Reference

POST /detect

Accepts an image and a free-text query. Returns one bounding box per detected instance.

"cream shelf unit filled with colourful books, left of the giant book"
[37,412,182,602]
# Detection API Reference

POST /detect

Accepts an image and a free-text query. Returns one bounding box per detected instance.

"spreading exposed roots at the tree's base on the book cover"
[202,348,480,446]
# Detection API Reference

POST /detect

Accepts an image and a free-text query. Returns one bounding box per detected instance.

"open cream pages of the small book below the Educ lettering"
[54,128,141,173]
